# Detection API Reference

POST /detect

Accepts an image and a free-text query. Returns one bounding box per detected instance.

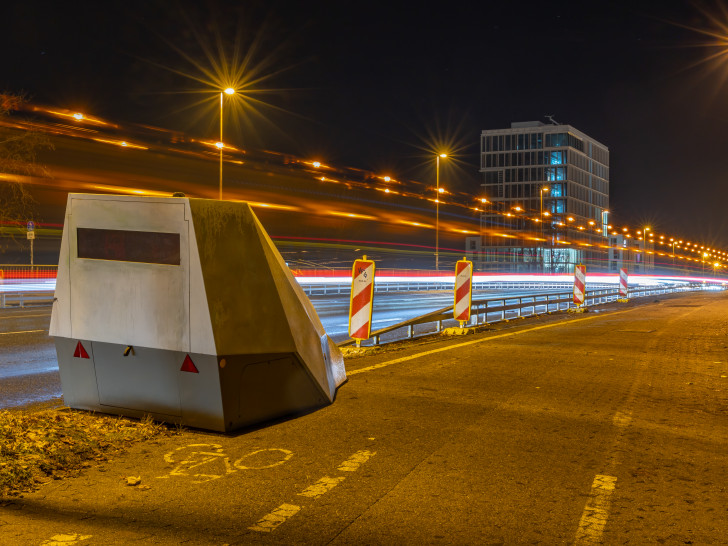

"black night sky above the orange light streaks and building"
[0,0,728,244]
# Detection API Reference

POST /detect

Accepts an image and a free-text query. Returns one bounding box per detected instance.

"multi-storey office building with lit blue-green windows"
[478,121,609,273]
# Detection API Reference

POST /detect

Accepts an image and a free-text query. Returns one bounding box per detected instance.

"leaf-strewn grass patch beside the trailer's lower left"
[0,410,173,497]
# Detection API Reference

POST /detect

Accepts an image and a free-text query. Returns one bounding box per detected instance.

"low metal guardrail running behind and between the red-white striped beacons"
[338,284,703,347]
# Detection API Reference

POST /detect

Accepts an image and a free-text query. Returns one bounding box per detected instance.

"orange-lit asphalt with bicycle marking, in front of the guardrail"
[0,293,728,545]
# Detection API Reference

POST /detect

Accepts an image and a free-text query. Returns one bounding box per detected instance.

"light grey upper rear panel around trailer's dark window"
[67,196,190,351]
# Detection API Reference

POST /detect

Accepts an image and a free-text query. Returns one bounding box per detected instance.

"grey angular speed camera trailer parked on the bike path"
[50,194,346,431]
